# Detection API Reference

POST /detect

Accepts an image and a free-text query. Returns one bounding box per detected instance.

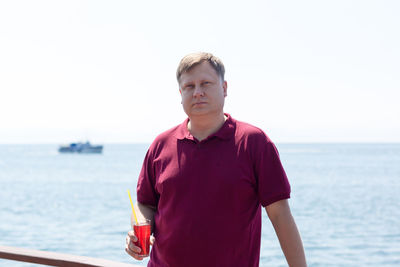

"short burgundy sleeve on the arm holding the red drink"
[136,148,159,207]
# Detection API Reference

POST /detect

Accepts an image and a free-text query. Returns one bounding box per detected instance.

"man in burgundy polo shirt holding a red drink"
[125,53,306,267]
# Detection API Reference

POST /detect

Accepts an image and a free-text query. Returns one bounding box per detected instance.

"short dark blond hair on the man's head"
[176,52,225,82]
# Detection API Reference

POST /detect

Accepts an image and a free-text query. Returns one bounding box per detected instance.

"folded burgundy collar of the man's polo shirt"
[175,113,236,141]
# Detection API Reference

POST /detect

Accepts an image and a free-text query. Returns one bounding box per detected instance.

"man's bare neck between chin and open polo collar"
[187,113,227,141]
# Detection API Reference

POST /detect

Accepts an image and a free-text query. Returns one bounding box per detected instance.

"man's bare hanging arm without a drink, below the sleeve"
[265,199,307,267]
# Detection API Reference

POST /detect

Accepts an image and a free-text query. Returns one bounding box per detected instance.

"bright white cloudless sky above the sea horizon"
[0,0,400,144]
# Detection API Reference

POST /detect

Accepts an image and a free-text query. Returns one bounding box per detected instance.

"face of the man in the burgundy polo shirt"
[179,61,227,118]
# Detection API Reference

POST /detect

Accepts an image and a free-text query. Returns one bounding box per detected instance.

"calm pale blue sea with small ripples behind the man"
[0,143,400,267]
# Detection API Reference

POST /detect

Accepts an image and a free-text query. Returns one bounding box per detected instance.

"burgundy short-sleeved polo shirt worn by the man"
[137,114,290,267]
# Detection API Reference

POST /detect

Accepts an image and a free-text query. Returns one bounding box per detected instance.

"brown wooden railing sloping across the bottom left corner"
[0,246,139,267]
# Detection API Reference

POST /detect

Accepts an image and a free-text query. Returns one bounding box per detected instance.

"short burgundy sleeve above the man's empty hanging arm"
[254,135,290,207]
